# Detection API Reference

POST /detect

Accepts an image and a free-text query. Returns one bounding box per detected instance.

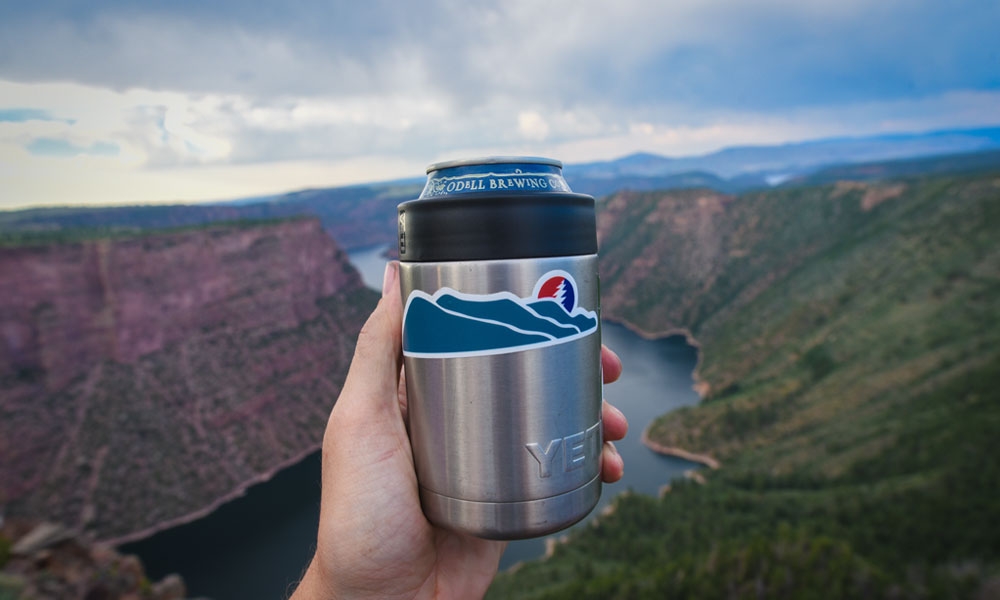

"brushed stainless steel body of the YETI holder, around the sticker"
[400,255,602,539]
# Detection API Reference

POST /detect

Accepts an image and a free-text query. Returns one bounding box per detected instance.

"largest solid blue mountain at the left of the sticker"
[403,297,551,354]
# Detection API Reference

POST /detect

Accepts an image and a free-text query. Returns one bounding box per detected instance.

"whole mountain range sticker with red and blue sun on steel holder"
[403,271,597,358]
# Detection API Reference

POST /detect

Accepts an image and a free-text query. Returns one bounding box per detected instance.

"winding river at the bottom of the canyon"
[121,246,698,600]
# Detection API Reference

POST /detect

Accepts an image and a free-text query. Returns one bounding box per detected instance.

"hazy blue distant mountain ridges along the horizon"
[0,127,1000,250]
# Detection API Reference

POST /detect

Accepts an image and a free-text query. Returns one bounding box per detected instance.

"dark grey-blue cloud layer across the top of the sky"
[0,1,1000,109]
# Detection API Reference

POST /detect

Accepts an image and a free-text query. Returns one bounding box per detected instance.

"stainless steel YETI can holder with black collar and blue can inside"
[398,157,602,539]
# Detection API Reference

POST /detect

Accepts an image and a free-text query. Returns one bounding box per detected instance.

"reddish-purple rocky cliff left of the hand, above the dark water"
[0,219,375,541]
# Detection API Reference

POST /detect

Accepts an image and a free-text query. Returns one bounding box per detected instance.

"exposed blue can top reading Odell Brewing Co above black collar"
[420,156,570,198]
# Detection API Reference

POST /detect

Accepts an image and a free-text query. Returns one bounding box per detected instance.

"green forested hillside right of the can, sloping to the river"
[491,172,1000,598]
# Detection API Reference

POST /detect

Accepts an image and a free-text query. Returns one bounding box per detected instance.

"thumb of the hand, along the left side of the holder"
[338,261,403,408]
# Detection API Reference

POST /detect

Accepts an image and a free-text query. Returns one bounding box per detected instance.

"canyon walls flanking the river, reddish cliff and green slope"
[0,151,1000,598]
